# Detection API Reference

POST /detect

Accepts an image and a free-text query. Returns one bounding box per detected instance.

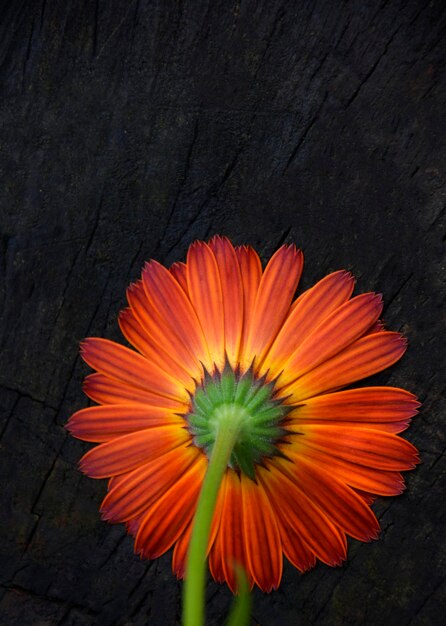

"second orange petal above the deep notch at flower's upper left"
[127,281,202,378]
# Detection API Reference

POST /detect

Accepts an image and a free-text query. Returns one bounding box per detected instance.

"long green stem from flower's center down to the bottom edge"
[183,405,246,626]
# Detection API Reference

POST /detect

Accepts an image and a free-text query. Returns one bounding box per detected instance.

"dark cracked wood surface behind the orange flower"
[0,0,446,626]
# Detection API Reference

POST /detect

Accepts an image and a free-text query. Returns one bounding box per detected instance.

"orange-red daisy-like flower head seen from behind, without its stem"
[68,237,419,591]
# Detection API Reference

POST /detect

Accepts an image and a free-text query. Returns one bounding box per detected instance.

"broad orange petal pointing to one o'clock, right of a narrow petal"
[244,246,303,363]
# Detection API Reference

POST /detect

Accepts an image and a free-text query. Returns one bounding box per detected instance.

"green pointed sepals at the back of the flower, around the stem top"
[185,364,292,480]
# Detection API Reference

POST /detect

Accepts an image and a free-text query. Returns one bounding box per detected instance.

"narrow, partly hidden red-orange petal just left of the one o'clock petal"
[235,246,262,366]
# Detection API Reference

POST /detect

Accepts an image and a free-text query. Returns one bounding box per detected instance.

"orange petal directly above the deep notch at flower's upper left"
[119,308,195,391]
